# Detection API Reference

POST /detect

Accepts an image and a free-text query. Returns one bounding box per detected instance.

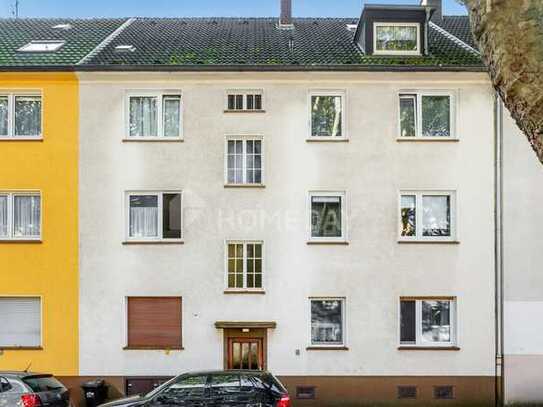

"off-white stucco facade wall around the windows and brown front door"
[80,73,494,375]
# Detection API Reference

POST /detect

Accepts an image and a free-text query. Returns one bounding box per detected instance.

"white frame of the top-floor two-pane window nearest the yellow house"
[123,89,185,142]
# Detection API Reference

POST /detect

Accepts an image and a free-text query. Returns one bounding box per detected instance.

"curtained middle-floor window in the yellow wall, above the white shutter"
[0,191,41,240]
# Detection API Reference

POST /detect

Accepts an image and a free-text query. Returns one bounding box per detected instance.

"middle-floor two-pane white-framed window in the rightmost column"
[400,191,456,241]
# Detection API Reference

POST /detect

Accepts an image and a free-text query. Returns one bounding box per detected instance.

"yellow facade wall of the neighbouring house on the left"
[0,73,79,375]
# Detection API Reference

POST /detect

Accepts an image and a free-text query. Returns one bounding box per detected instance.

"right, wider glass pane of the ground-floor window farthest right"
[422,301,451,342]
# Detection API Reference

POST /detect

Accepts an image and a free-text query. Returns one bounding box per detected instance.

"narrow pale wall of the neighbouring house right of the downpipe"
[503,107,543,402]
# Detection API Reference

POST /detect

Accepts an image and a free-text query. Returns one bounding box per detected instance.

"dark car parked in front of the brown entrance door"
[101,370,290,407]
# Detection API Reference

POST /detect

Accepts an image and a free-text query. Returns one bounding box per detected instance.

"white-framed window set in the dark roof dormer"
[373,23,421,55]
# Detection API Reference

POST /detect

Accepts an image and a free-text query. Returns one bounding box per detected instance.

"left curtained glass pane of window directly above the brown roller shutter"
[129,195,158,237]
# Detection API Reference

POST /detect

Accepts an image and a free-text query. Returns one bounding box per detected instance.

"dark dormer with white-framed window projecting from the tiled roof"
[355,4,434,56]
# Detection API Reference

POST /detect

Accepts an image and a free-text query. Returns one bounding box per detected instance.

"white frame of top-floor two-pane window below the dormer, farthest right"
[397,89,458,141]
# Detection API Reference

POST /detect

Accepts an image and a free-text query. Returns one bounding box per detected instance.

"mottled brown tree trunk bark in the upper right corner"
[463,0,543,163]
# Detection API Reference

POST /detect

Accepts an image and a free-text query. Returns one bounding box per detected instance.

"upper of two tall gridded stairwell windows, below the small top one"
[225,137,263,185]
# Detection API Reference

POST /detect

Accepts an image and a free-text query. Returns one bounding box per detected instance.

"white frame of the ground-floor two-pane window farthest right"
[398,296,459,348]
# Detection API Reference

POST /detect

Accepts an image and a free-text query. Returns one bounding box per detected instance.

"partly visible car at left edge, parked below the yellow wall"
[0,371,71,407]
